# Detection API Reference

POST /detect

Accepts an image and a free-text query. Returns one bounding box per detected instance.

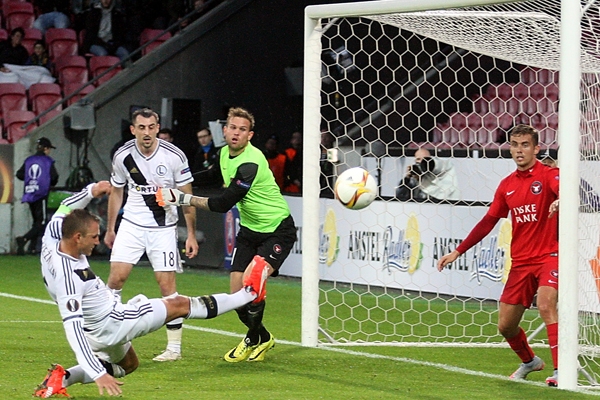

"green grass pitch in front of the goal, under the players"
[0,256,600,400]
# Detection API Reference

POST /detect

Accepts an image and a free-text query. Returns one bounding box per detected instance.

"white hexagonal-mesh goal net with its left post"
[303,0,600,383]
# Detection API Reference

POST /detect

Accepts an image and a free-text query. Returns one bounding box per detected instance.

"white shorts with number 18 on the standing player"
[110,220,182,272]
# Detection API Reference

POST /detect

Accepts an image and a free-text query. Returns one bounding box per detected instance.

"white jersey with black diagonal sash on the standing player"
[110,139,194,228]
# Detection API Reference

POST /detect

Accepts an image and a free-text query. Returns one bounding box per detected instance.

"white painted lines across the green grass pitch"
[0,292,600,396]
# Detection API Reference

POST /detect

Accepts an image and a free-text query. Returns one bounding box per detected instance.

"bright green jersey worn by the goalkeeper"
[219,142,290,233]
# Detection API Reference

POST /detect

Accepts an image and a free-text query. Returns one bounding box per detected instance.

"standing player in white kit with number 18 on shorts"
[104,108,198,361]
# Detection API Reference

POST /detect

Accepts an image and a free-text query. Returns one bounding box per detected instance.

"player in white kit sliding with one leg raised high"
[34,181,267,398]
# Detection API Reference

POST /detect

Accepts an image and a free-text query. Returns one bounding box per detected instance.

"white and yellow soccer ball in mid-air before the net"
[333,167,377,210]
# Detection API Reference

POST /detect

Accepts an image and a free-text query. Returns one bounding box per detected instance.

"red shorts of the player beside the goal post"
[500,256,558,308]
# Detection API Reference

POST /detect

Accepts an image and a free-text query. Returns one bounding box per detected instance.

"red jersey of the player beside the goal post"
[488,161,559,265]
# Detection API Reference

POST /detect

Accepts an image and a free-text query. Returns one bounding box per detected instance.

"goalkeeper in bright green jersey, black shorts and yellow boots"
[156,108,296,362]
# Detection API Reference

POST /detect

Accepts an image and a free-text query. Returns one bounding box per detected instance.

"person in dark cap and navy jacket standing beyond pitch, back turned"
[17,137,58,255]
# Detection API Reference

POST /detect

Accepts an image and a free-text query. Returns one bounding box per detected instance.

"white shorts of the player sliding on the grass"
[85,295,167,363]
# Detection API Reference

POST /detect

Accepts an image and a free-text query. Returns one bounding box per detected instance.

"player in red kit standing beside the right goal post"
[437,125,559,386]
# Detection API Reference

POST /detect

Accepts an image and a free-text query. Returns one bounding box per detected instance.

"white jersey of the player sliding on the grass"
[40,212,119,380]
